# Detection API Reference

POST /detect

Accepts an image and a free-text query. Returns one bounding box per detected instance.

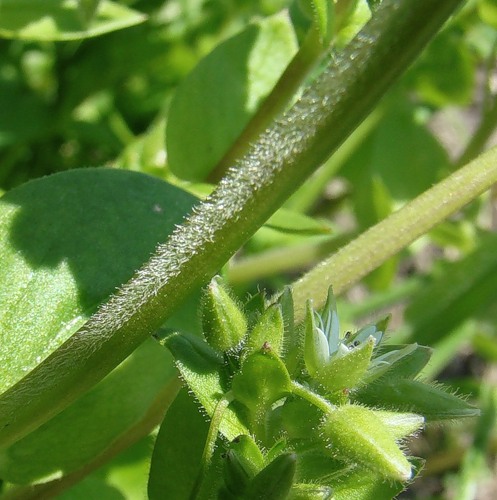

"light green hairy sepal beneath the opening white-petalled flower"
[314,337,375,392]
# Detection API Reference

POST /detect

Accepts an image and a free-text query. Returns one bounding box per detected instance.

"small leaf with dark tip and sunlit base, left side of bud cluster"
[163,333,248,440]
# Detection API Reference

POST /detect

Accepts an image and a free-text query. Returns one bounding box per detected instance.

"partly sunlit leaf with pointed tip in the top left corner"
[0,0,146,41]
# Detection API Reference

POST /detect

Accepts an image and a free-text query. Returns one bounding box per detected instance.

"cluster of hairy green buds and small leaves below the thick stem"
[163,279,478,499]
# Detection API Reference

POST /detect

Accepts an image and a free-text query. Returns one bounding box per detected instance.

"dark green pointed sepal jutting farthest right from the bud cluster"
[353,379,480,422]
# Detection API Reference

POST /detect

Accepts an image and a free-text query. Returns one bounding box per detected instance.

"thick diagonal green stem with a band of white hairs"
[0,0,461,446]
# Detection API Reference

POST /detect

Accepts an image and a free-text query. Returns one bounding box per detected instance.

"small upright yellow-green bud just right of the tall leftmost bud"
[244,304,285,355]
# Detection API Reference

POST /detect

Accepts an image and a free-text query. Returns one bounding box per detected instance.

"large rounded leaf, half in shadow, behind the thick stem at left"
[0,169,196,444]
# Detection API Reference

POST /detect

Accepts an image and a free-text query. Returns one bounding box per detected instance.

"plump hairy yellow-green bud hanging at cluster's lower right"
[322,405,412,481]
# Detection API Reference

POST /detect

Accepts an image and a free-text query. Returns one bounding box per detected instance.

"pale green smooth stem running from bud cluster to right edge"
[293,148,497,321]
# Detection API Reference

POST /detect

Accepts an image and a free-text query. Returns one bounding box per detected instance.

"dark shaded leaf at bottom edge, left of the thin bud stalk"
[148,388,209,500]
